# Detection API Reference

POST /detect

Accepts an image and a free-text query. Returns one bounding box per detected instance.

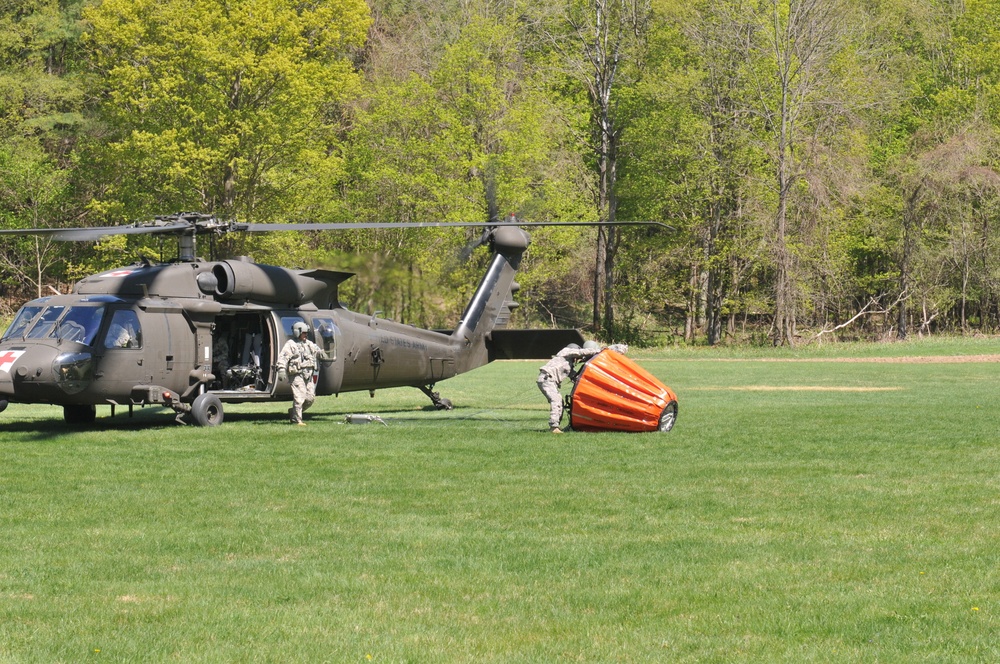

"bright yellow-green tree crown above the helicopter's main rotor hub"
[85,0,368,226]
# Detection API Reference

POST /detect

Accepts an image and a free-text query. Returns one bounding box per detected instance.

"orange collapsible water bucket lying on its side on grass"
[570,348,677,432]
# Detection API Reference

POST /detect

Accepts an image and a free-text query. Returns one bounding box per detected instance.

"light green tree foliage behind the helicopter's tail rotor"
[341,17,585,326]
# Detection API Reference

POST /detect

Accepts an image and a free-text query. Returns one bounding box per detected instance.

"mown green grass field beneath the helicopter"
[0,339,1000,663]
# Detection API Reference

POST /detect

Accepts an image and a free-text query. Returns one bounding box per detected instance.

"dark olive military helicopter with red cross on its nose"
[0,213,665,426]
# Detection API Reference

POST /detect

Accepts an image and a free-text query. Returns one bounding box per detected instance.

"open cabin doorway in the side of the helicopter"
[209,312,274,395]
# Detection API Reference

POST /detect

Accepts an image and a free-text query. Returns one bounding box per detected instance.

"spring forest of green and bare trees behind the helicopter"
[0,0,1000,345]
